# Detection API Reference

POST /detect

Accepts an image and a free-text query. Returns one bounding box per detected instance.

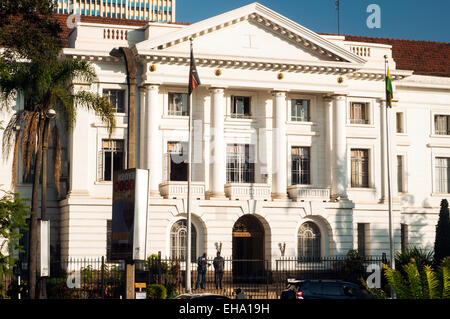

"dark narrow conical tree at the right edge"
[434,199,450,265]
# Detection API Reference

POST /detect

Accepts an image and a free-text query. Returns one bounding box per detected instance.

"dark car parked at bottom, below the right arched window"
[281,279,374,300]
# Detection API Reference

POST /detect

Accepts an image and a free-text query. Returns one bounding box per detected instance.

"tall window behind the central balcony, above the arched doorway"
[227,144,255,183]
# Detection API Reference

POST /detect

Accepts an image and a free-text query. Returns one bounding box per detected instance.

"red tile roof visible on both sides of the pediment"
[55,14,450,77]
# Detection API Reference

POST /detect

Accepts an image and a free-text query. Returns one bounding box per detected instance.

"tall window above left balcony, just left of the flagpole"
[167,142,189,182]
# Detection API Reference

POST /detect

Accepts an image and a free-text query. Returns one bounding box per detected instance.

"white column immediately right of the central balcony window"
[272,91,287,199]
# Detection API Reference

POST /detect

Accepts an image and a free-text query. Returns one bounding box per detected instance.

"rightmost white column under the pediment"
[331,94,347,199]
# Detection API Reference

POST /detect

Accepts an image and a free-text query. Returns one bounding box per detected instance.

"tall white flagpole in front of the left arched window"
[186,38,194,293]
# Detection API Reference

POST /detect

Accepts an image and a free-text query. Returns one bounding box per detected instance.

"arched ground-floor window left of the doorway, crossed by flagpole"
[170,219,197,261]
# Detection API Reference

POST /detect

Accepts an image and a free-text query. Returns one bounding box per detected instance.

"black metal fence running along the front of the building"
[2,255,387,299]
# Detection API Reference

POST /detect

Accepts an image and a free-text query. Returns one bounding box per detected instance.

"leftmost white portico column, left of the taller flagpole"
[144,85,163,197]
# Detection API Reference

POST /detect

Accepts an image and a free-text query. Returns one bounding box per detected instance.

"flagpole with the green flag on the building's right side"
[384,55,395,276]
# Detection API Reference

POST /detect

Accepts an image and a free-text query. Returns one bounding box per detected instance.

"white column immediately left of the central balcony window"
[208,88,227,198]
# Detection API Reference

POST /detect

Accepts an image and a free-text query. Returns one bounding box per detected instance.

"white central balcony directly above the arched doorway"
[225,183,271,201]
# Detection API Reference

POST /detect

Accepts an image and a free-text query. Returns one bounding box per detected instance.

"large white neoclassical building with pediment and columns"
[0,3,450,266]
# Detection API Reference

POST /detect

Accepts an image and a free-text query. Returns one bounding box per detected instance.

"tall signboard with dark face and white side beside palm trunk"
[111,168,149,261]
